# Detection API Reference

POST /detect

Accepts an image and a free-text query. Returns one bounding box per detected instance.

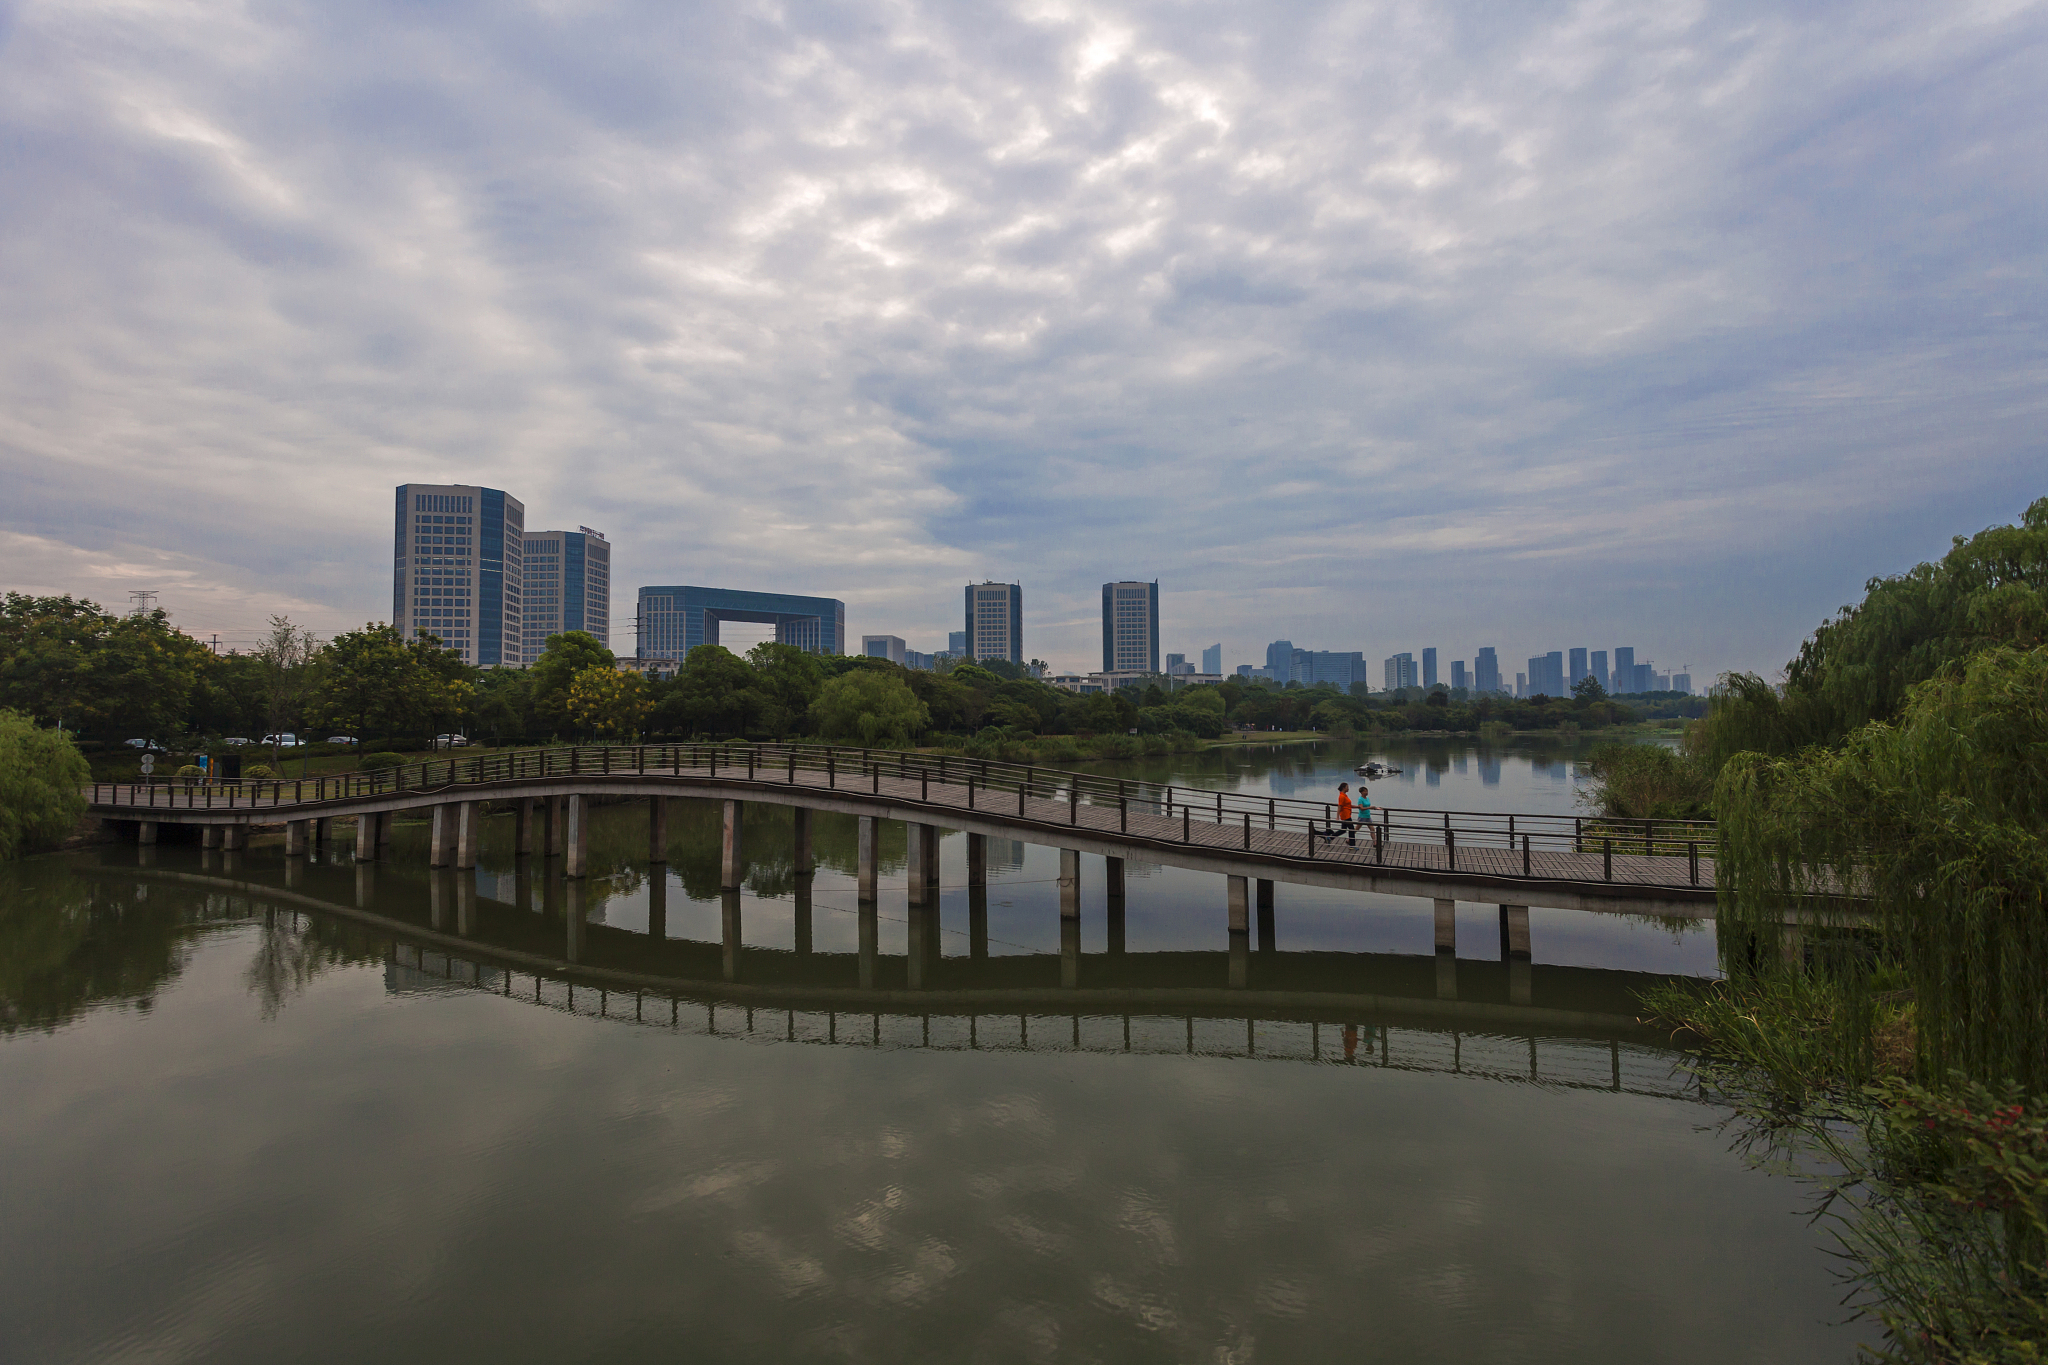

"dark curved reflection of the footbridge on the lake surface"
[109,870,1698,1099]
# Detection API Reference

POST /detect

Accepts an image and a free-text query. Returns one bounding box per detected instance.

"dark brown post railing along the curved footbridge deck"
[92,743,1714,884]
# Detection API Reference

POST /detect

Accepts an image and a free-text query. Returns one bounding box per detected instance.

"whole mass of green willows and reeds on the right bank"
[1647,499,2048,1363]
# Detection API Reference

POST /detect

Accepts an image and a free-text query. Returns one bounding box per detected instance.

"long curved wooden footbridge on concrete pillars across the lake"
[88,745,1714,984]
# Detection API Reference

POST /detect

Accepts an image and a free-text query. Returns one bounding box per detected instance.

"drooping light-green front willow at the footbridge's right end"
[1714,647,2048,1091]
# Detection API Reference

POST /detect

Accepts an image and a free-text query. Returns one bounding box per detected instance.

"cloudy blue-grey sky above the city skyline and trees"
[0,0,2048,679]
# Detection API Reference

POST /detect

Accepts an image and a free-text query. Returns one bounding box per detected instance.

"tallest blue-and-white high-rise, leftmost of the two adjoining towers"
[391,483,526,667]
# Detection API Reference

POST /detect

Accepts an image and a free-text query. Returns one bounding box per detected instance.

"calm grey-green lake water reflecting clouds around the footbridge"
[0,740,1868,1363]
